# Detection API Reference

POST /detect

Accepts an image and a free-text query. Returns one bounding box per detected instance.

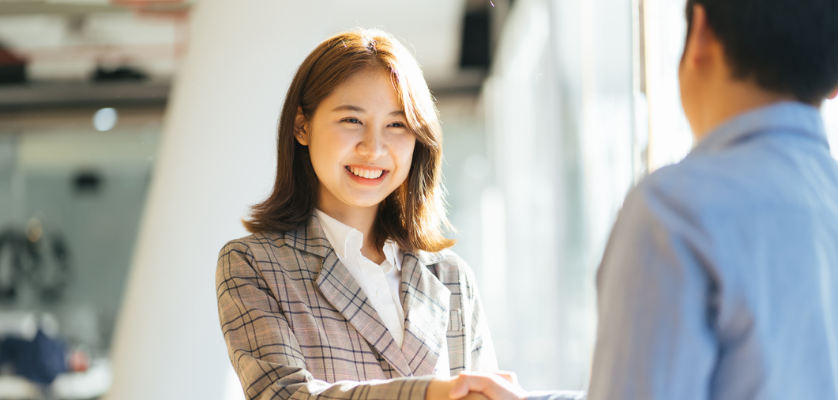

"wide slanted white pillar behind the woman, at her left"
[105,0,329,400]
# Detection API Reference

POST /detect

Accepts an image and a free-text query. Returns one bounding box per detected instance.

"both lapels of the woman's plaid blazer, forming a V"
[285,216,451,376]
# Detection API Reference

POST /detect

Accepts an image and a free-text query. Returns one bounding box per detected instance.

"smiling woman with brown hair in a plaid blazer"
[216,30,496,399]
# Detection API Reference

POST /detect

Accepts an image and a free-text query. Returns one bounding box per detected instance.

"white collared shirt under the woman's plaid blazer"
[314,209,451,377]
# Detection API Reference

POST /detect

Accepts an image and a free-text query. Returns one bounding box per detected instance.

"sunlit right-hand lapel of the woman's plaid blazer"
[401,252,451,375]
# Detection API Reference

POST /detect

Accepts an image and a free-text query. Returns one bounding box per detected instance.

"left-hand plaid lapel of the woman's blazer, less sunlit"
[286,216,413,376]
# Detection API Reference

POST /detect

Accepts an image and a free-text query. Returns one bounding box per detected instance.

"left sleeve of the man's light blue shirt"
[588,186,717,400]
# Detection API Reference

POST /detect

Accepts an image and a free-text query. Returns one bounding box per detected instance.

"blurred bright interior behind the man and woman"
[0,0,838,400]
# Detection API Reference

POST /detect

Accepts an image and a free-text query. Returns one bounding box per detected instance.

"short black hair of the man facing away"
[687,0,838,105]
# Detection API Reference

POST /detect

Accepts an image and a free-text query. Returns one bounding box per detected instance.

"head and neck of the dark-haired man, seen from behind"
[680,0,838,139]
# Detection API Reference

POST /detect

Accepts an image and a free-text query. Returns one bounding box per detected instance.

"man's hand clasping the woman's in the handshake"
[450,372,527,400]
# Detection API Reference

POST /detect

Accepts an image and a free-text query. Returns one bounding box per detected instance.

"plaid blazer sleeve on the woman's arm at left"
[216,241,432,400]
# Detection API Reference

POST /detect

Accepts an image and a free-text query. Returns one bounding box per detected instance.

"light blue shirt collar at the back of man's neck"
[691,101,829,153]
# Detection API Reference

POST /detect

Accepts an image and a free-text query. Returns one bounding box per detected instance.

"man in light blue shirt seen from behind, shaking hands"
[451,0,838,400]
